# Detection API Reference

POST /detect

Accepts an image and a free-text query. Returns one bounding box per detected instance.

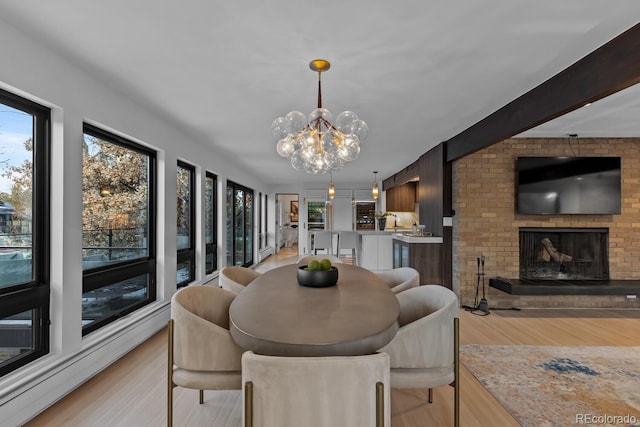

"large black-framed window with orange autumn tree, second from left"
[82,124,156,335]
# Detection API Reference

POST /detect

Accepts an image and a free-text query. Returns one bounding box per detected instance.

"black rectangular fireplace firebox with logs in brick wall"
[520,228,609,280]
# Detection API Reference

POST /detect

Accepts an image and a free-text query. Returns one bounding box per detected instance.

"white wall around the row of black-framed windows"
[0,17,273,426]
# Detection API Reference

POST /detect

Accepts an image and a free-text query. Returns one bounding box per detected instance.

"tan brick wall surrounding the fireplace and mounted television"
[453,138,640,307]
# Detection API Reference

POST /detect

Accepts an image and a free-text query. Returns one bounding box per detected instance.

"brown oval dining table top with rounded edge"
[229,263,400,356]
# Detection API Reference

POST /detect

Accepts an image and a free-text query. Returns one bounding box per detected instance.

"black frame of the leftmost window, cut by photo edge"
[0,89,51,376]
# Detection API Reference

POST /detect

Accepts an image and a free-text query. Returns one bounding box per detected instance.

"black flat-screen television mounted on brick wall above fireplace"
[516,157,622,214]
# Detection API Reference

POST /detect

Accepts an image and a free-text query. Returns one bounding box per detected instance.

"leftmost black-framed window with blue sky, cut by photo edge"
[0,90,50,375]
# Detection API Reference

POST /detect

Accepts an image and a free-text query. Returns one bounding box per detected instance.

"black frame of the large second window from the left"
[82,122,157,336]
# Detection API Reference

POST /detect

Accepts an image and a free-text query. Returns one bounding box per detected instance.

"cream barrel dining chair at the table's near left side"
[167,285,244,426]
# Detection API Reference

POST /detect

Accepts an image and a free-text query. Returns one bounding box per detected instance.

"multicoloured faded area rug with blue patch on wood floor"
[460,344,640,427]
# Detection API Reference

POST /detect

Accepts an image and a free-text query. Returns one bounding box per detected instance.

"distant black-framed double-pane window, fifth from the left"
[227,181,253,267]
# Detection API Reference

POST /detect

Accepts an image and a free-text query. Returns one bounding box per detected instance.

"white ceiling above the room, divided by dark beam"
[0,0,640,184]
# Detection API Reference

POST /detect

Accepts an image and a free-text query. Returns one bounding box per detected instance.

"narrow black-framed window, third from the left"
[176,161,196,287]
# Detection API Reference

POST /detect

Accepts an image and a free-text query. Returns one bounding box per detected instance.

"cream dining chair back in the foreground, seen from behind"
[242,351,391,427]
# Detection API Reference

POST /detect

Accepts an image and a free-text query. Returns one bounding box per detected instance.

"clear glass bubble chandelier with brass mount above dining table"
[271,59,369,174]
